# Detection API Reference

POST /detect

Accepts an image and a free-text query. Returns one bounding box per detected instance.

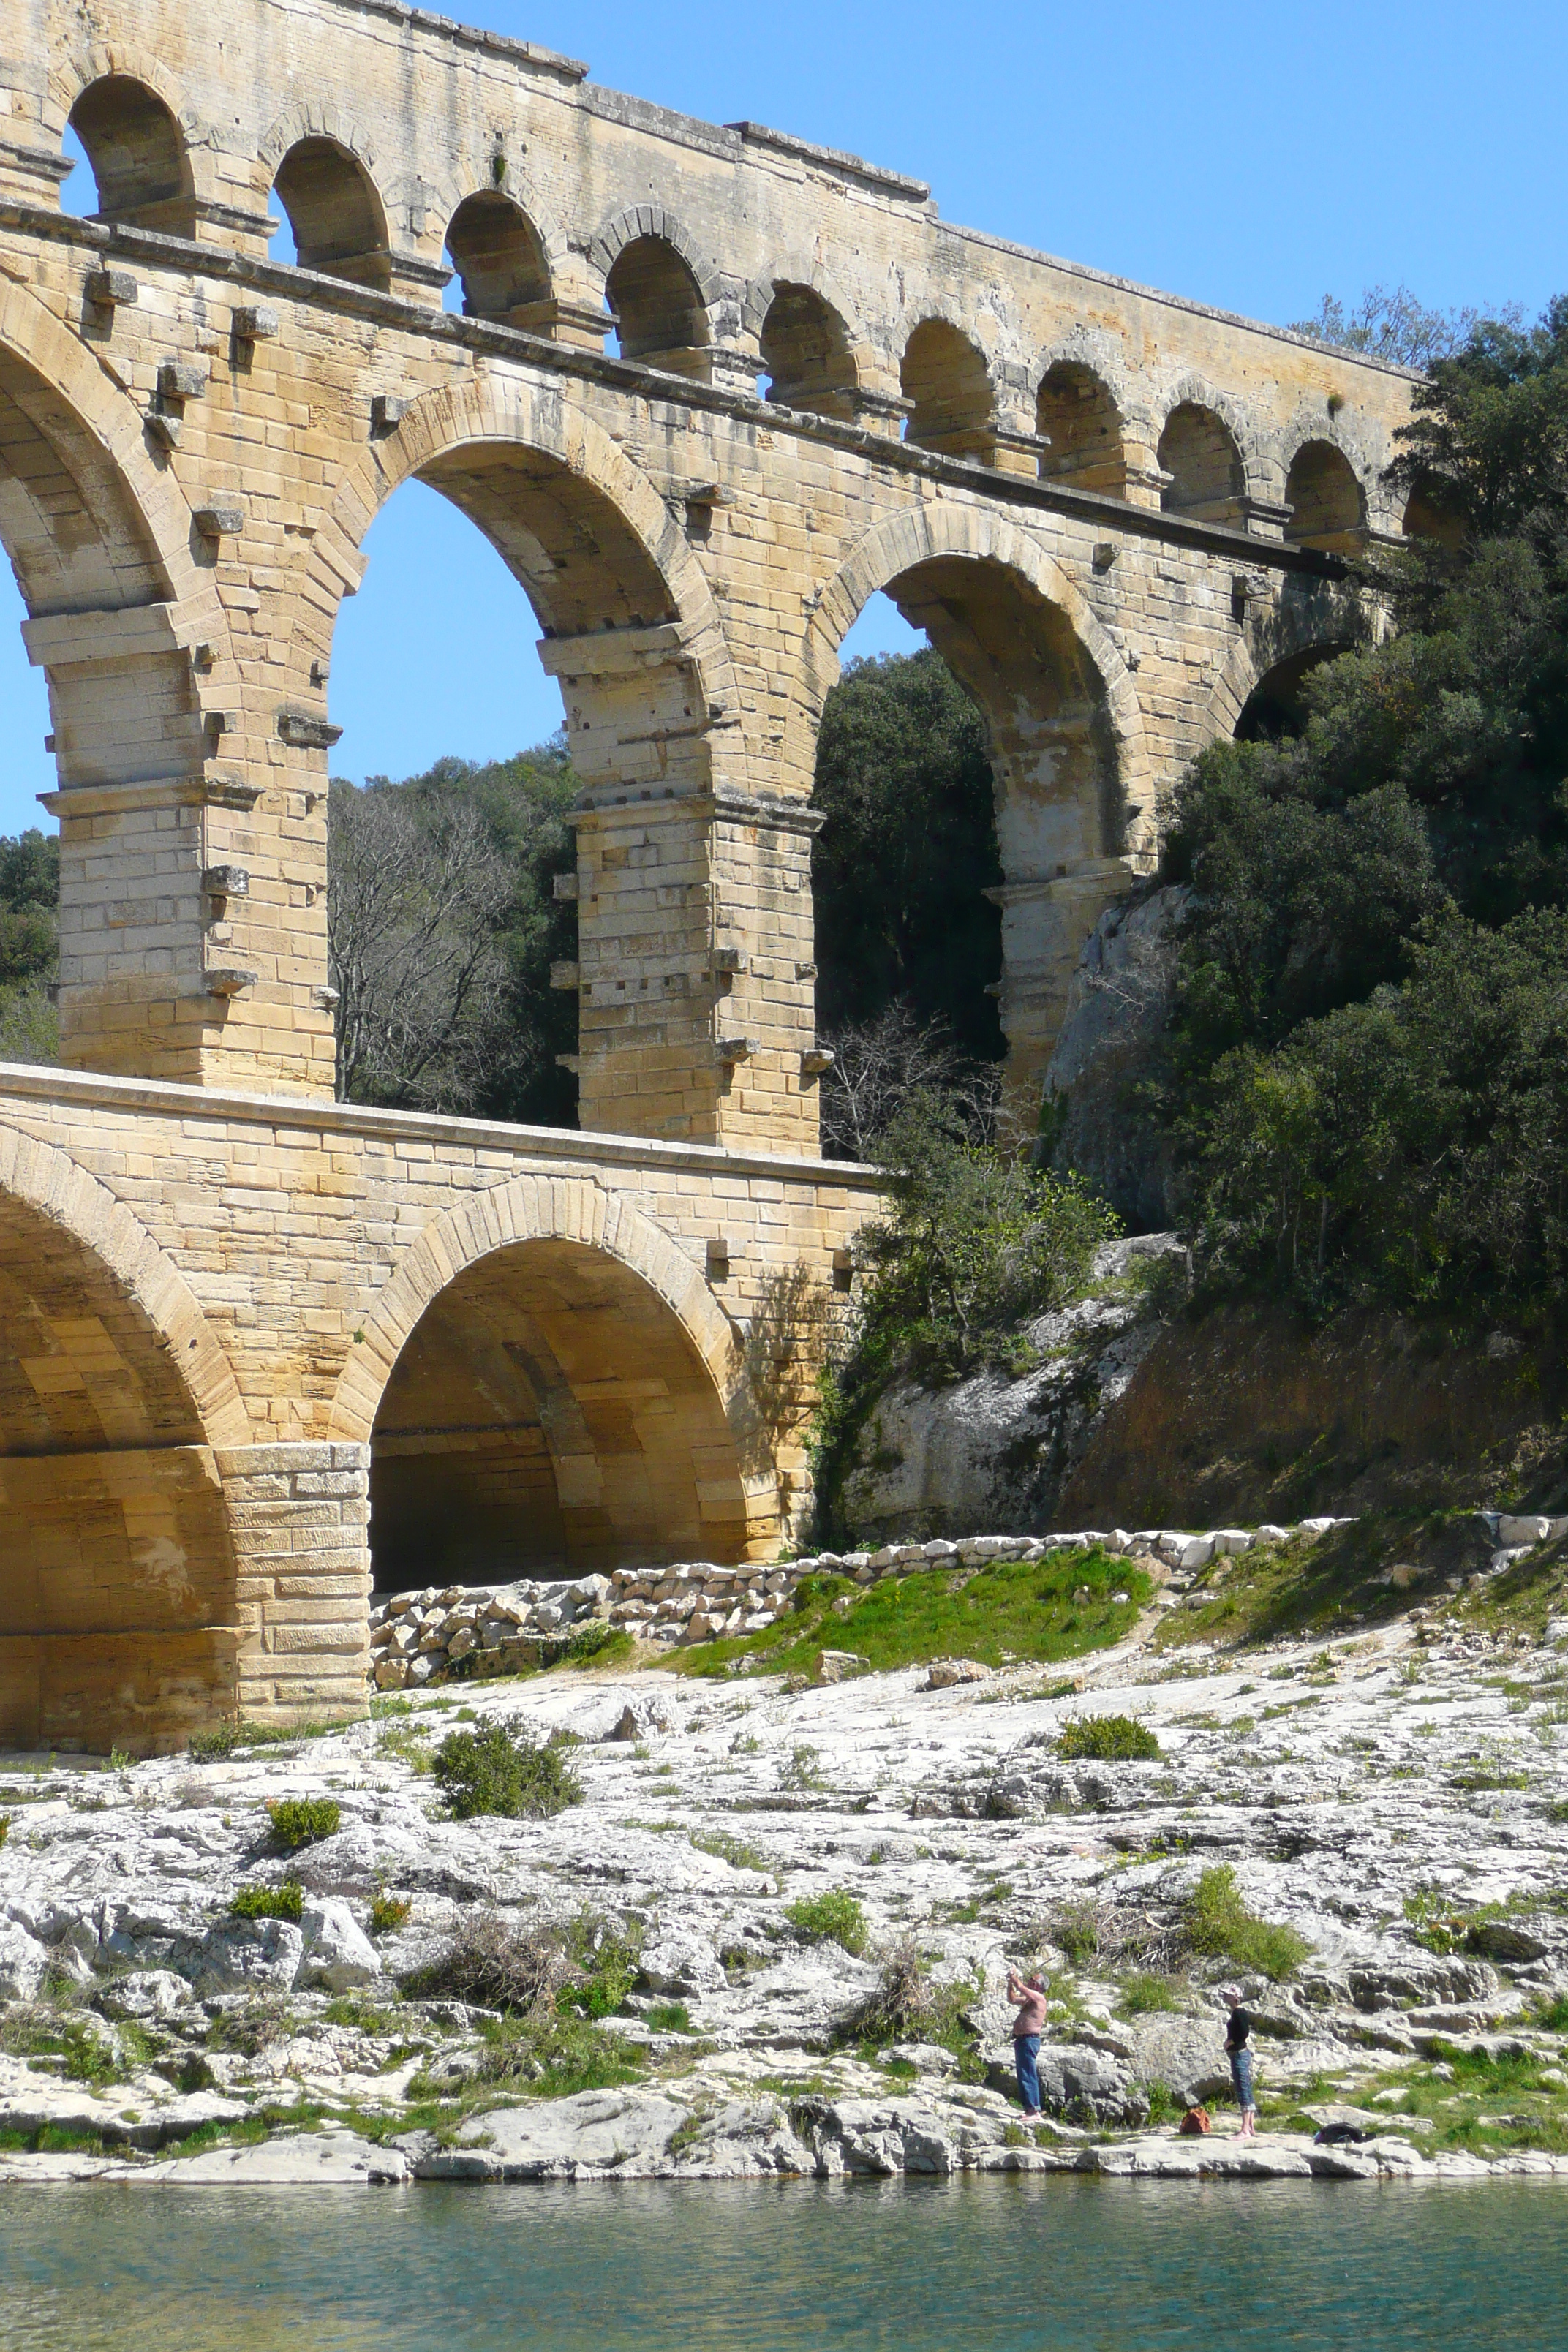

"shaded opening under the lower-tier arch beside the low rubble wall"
[372,1240,747,1592]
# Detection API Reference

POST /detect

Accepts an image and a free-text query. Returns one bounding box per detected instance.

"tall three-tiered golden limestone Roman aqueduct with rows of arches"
[0,0,1411,1747]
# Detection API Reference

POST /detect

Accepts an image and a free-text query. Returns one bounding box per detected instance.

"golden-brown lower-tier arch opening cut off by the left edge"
[0,1193,240,1754]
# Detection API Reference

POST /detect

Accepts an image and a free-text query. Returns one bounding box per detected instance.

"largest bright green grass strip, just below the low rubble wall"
[670,1550,1154,1675]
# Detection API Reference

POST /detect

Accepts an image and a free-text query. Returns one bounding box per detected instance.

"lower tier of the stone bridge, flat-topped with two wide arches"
[0,1066,877,1747]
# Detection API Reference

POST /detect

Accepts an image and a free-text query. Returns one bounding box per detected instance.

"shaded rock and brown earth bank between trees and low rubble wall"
[840,1279,1568,1543]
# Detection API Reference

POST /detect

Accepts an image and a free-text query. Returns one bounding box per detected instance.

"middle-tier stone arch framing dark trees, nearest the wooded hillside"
[785,501,1156,1110]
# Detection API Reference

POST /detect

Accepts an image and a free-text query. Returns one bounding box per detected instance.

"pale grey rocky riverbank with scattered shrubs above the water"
[0,1529,1568,2182]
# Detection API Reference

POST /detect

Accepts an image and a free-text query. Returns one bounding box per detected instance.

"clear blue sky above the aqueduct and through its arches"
[0,0,1568,832]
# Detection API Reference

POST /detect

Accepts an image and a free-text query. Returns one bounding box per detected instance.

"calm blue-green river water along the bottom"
[0,2178,1568,2352]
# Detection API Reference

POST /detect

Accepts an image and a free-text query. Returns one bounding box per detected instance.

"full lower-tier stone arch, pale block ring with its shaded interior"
[331,1176,776,1586]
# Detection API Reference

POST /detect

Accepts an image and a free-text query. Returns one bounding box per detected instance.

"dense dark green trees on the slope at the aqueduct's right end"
[1164,301,1568,1319]
